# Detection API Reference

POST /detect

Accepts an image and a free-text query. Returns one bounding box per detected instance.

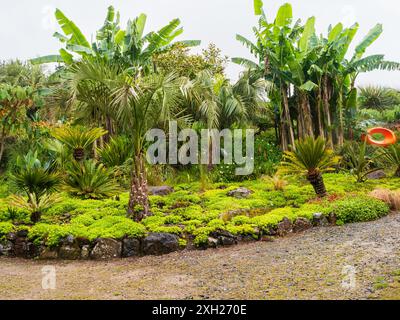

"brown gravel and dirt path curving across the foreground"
[0,215,400,299]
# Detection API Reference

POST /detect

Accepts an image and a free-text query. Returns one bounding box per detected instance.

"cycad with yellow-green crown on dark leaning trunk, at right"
[280,137,339,197]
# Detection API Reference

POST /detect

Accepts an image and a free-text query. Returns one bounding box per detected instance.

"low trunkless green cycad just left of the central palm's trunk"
[65,160,120,199]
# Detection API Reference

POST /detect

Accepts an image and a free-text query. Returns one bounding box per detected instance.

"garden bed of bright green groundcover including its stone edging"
[0,174,394,260]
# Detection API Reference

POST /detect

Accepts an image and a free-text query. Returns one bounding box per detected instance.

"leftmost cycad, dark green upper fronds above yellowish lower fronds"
[11,151,61,223]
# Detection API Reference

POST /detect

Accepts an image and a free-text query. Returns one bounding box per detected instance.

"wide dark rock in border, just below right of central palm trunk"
[142,233,179,255]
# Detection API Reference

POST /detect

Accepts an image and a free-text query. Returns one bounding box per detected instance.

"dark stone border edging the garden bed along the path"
[0,213,336,260]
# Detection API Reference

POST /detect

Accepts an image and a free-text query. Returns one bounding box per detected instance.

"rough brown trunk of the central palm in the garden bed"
[128,153,150,222]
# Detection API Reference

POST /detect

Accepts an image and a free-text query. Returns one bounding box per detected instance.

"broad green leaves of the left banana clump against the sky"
[31,6,200,72]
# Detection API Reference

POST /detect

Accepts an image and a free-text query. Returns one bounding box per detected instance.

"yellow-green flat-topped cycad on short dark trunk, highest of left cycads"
[51,126,107,162]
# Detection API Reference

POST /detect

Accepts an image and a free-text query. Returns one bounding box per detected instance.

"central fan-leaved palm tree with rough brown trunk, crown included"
[114,74,187,221]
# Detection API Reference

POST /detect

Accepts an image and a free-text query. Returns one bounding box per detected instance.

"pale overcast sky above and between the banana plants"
[0,0,400,88]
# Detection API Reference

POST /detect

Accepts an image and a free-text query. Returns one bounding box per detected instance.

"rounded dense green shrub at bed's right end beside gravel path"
[332,196,389,223]
